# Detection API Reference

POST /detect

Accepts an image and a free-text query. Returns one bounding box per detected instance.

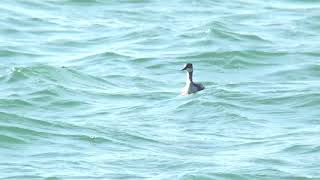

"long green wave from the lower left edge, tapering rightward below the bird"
[0,112,166,150]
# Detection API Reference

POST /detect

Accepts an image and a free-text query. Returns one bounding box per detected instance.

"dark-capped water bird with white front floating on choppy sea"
[181,63,204,96]
